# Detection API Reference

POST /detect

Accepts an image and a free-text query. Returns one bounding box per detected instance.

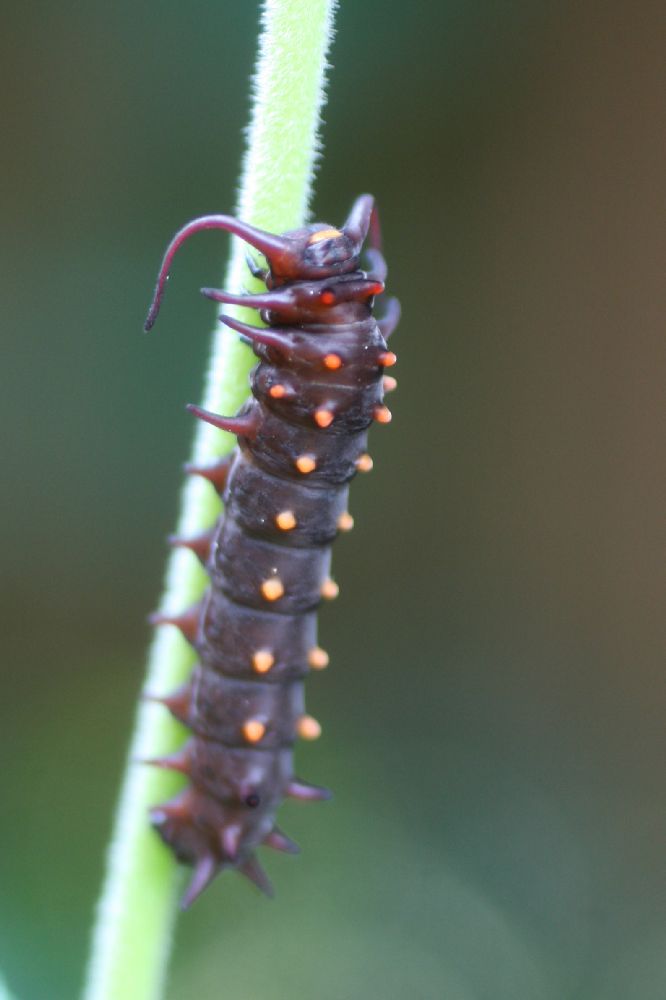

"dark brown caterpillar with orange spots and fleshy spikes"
[146,195,400,907]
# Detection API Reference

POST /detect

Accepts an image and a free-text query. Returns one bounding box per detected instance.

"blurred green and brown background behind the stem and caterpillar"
[0,0,666,1000]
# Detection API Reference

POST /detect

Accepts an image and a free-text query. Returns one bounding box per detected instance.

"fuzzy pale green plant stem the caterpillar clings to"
[84,0,336,1000]
